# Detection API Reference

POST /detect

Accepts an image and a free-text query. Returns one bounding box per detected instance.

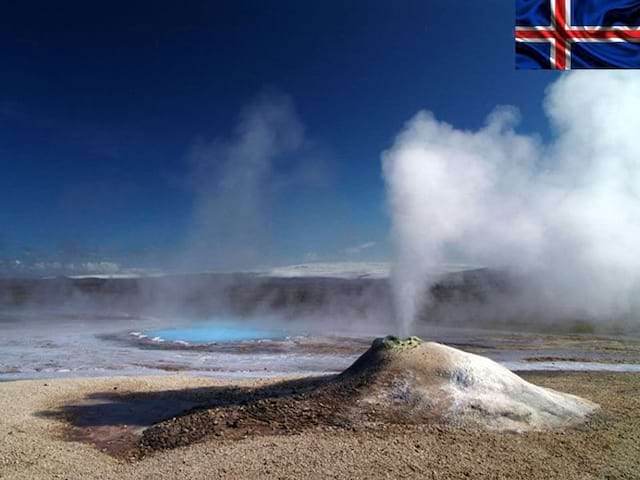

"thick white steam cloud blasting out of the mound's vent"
[382,72,640,331]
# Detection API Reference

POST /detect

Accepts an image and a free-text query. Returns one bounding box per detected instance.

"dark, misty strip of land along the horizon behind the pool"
[0,269,638,338]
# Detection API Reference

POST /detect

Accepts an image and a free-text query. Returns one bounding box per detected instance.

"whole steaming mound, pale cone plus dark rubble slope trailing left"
[140,337,598,453]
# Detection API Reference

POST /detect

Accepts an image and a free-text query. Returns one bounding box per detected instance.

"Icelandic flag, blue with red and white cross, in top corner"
[515,0,640,70]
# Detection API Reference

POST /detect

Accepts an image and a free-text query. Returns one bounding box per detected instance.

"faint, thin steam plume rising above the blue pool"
[187,94,305,269]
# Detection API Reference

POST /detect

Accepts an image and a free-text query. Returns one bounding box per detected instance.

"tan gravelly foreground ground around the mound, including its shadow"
[0,372,640,479]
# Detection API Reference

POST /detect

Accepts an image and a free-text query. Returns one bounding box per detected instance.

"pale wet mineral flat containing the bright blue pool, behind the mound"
[0,311,640,381]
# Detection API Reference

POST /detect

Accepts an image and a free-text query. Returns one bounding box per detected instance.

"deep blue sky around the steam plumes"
[0,0,556,267]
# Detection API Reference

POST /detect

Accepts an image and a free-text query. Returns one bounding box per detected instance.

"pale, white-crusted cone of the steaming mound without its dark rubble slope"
[337,337,598,430]
